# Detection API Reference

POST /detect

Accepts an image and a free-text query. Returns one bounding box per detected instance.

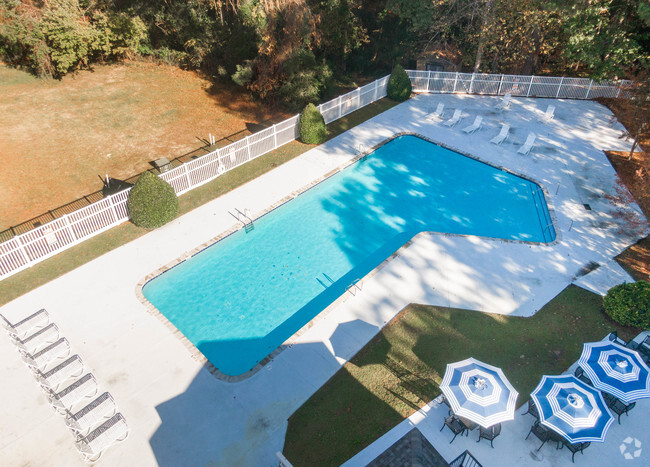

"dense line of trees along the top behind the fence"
[0,0,650,109]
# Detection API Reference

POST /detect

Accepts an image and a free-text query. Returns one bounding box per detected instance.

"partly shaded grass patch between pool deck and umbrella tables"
[284,285,636,466]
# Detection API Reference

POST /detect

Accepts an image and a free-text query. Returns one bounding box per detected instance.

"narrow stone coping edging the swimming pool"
[135,132,561,383]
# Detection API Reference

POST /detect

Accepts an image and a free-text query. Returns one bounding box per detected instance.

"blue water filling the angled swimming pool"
[143,136,555,375]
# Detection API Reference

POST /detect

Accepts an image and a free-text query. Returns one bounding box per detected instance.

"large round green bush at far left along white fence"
[127,172,178,229]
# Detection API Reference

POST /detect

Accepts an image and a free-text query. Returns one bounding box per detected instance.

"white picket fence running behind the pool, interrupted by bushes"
[0,71,621,280]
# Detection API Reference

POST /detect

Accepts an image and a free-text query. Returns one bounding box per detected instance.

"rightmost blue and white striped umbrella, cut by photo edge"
[578,341,650,404]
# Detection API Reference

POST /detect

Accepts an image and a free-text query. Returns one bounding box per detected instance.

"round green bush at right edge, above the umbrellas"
[604,281,650,329]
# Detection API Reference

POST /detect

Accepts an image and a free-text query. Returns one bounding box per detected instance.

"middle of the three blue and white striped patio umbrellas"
[530,375,614,443]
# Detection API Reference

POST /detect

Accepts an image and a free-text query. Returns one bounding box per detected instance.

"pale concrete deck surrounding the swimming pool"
[0,95,650,466]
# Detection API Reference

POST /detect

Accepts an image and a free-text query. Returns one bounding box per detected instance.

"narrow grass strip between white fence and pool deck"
[0,99,397,306]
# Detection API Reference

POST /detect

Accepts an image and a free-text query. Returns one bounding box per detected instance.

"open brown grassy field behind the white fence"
[0,62,285,230]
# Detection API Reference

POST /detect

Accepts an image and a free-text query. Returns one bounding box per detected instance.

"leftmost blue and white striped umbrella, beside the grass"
[440,358,519,428]
